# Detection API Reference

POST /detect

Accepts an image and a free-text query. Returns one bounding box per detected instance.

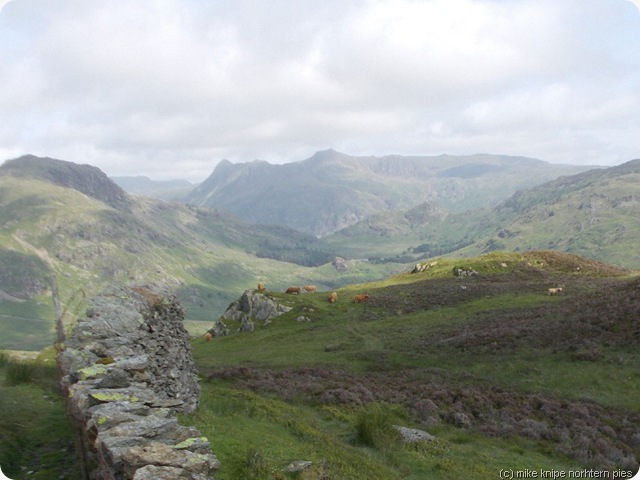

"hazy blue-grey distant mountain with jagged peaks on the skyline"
[185,150,589,237]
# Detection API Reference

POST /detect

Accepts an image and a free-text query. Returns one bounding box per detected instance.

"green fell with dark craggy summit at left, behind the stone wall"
[0,156,404,349]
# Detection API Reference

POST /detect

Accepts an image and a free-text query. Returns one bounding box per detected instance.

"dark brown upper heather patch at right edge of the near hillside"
[408,278,640,354]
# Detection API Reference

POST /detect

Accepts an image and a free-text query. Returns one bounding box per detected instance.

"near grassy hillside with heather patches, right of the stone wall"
[189,252,640,479]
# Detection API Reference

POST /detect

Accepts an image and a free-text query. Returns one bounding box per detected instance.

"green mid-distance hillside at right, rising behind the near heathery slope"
[323,160,640,268]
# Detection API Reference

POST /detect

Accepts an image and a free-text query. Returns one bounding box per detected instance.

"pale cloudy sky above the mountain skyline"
[0,0,640,182]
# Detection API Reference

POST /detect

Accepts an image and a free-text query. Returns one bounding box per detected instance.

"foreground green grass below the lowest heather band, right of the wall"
[181,380,579,480]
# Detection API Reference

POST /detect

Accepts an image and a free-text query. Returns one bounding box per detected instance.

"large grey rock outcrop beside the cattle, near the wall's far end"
[209,290,292,336]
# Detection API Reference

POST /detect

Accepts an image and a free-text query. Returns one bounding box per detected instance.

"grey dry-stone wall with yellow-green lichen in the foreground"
[58,288,219,480]
